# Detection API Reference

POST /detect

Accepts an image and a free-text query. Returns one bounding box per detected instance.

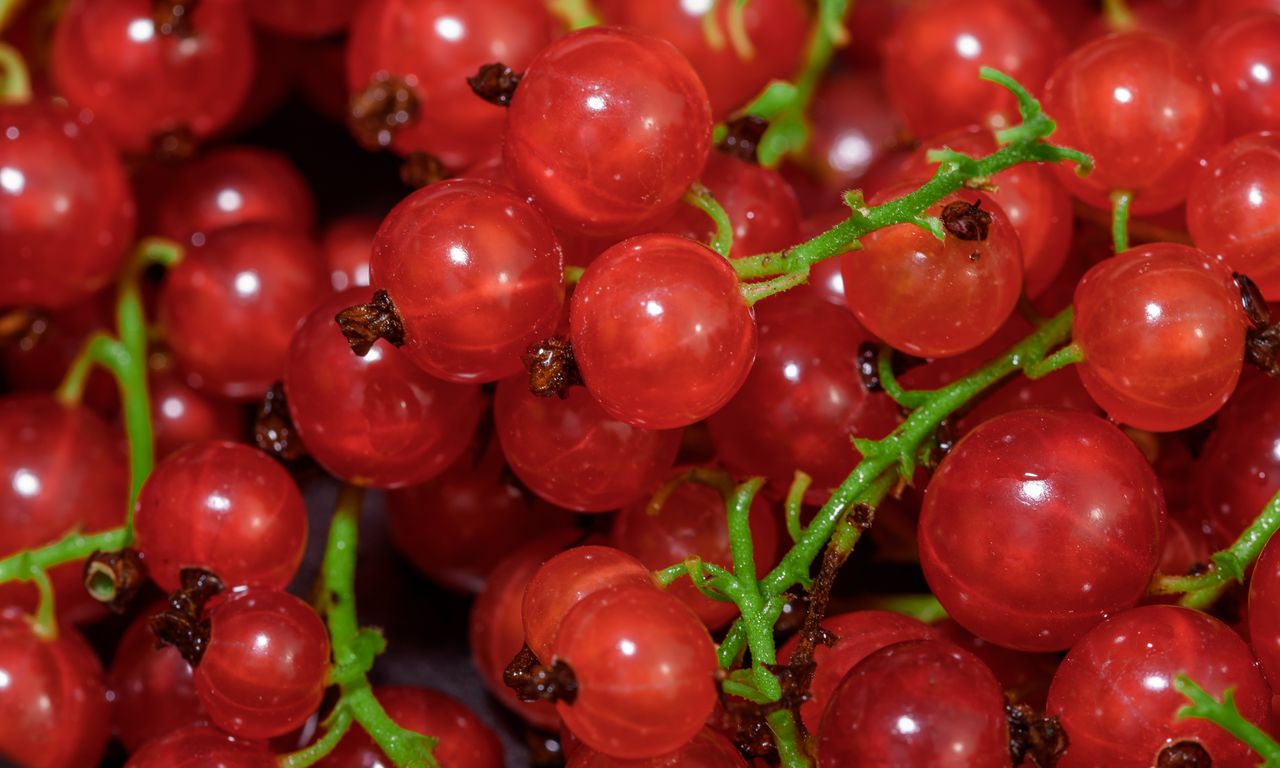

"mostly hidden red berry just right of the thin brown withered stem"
[778,611,941,732]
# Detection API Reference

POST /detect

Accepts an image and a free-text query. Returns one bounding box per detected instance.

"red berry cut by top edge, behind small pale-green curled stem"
[595,0,810,119]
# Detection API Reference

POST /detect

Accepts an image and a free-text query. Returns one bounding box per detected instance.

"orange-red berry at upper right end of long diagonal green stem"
[1073,243,1248,431]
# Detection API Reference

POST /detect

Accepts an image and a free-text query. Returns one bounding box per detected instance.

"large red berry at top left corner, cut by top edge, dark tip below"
[52,0,253,152]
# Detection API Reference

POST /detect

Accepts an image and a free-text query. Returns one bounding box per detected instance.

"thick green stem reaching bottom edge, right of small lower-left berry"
[320,485,439,768]
